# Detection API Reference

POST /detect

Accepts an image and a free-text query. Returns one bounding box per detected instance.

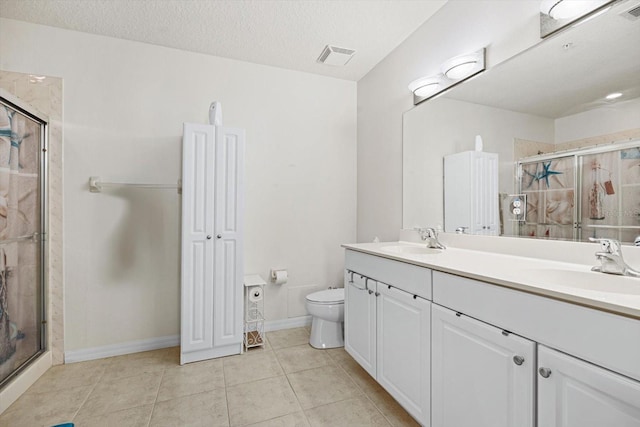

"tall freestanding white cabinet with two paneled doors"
[180,123,244,363]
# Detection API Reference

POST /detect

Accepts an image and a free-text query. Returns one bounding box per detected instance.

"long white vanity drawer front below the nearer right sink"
[433,271,640,380]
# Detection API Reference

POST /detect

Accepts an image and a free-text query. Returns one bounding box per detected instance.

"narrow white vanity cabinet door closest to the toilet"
[344,272,376,378]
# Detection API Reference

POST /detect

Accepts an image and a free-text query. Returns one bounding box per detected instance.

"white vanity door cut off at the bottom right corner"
[538,346,640,427]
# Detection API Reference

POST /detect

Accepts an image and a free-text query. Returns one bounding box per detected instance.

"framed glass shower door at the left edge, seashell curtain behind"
[0,94,47,387]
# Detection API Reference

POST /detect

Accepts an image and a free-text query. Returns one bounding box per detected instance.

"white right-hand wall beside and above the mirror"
[358,0,540,242]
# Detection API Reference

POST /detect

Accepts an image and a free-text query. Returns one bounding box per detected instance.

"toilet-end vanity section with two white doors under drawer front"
[345,251,431,426]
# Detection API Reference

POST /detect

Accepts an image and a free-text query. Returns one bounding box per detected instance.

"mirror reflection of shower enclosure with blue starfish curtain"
[516,140,640,243]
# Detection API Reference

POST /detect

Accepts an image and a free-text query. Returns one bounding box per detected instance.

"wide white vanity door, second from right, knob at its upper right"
[431,304,536,427]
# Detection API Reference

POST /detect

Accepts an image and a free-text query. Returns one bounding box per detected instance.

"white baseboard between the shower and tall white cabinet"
[64,335,180,363]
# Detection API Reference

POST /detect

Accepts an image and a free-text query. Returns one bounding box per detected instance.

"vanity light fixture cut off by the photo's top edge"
[540,0,616,38]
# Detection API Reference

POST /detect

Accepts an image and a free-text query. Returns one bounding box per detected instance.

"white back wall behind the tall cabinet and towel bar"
[0,19,356,351]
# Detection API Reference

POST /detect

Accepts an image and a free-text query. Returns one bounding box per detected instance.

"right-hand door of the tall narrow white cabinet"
[213,127,244,347]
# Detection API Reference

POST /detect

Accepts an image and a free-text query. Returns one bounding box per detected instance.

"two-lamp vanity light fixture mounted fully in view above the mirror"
[409,48,485,105]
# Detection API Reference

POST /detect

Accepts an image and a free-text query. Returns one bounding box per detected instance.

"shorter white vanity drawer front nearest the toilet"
[345,250,431,300]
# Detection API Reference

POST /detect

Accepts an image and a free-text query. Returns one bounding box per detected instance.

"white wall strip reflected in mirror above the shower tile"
[555,98,640,144]
